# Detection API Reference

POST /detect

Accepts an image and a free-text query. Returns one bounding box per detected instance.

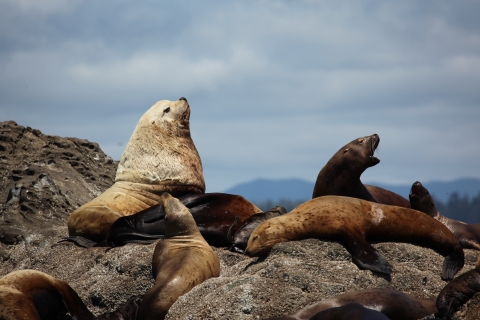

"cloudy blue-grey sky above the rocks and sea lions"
[0,0,480,192]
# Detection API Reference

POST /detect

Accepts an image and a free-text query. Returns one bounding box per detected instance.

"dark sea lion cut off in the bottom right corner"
[436,256,480,320]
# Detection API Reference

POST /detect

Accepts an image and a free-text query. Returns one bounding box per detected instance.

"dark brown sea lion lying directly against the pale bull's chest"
[64,193,262,248]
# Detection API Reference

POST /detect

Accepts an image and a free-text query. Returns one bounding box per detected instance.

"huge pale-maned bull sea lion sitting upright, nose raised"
[68,98,205,242]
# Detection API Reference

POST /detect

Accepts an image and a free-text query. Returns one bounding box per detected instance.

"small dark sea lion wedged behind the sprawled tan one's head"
[227,206,287,253]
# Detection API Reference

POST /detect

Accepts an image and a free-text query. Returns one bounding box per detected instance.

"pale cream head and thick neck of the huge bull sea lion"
[115,98,205,189]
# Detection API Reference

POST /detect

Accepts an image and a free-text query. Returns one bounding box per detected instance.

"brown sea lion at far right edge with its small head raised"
[409,181,480,250]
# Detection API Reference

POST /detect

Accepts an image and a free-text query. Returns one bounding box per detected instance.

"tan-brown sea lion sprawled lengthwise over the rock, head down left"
[245,196,464,279]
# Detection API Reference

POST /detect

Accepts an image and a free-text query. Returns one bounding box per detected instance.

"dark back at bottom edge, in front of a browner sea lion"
[309,303,390,320]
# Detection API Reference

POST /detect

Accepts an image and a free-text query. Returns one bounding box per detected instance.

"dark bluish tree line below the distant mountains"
[256,192,480,223]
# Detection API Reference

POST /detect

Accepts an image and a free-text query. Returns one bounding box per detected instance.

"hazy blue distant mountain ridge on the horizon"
[225,178,480,203]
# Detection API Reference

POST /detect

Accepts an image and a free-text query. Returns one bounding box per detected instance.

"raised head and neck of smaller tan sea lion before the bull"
[160,192,200,239]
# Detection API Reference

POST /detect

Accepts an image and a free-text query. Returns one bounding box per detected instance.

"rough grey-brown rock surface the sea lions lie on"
[0,121,480,320]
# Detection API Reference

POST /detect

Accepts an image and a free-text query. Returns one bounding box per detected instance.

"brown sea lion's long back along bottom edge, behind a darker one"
[271,288,437,320]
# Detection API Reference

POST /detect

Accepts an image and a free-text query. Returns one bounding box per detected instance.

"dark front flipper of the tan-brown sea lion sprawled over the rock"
[341,231,392,274]
